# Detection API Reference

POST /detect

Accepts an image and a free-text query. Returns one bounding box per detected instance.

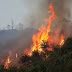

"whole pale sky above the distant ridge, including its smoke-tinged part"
[0,0,72,28]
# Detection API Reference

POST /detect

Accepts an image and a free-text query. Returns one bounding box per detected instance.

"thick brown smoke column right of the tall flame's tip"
[52,0,72,37]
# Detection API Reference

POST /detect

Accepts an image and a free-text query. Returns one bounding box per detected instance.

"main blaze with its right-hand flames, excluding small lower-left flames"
[25,3,64,56]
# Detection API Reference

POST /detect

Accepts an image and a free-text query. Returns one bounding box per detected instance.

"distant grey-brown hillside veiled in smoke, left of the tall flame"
[0,28,38,58]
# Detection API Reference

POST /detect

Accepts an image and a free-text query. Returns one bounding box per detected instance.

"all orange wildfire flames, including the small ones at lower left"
[0,3,64,69]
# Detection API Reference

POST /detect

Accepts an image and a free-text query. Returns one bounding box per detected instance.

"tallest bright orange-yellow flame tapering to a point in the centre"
[27,3,56,53]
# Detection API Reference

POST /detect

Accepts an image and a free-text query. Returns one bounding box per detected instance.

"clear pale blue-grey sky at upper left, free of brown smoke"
[0,0,28,28]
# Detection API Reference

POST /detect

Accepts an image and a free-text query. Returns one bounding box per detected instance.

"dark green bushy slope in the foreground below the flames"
[0,37,72,72]
